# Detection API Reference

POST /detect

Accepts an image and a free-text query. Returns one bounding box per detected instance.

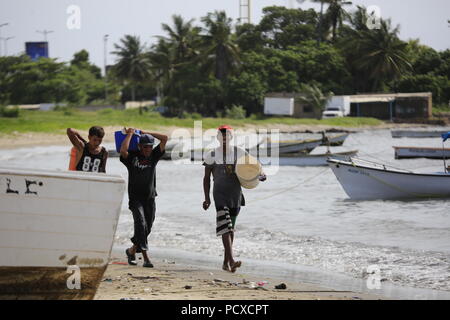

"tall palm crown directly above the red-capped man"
[202,11,240,81]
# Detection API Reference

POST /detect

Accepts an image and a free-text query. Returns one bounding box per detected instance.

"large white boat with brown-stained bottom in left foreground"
[0,168,125,299]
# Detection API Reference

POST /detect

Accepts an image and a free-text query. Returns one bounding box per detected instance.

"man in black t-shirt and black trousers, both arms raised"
[120,128,168,268]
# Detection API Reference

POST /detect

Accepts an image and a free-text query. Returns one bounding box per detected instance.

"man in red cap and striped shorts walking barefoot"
[203,125,266,272]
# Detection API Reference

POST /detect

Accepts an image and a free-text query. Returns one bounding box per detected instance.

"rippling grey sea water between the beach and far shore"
[0,129,450,293]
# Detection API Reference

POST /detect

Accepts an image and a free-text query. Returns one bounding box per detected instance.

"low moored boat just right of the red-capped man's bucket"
[259,150,358,167]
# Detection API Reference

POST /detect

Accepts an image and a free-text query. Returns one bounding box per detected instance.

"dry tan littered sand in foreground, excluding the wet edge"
[95,252,385,300]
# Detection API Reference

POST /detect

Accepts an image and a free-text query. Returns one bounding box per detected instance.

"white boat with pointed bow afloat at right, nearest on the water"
[328,158,450,200]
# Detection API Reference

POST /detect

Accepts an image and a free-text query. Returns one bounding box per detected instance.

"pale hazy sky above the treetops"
[0,0,450,67]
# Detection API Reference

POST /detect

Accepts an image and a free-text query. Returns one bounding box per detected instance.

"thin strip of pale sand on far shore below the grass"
[0,123,436,149]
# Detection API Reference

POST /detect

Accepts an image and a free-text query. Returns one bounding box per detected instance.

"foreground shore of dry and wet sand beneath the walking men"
[95,245,450,300]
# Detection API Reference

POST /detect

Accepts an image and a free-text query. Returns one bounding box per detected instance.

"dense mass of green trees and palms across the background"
[0,0,450,122]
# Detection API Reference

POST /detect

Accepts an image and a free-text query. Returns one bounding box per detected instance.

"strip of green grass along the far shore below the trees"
[0,109,383,134]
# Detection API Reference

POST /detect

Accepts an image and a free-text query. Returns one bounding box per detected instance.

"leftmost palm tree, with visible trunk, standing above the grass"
[113,35,151,101]
